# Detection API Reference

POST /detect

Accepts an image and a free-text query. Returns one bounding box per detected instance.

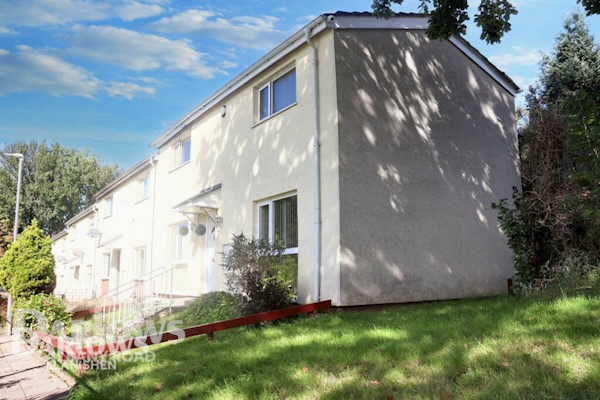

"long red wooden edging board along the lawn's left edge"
[34,300,331,360]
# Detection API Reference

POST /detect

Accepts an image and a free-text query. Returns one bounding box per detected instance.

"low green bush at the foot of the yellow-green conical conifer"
[14,293,71,336]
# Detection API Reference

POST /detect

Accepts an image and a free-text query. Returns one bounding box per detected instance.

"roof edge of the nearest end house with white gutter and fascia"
[151,11,520,148]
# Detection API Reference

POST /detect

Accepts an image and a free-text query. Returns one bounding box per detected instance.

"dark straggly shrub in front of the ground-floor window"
[223,233,295,315]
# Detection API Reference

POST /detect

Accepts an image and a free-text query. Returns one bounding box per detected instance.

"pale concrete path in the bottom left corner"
[0,335,70,400]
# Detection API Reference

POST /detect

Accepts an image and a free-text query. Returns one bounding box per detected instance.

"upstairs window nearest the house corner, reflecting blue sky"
[258,69,296,121]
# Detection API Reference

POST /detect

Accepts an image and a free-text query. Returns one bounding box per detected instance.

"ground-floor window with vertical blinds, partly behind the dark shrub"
[258,195,298,254]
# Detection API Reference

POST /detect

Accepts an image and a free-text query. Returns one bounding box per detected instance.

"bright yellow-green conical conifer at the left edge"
[0,219,56,298]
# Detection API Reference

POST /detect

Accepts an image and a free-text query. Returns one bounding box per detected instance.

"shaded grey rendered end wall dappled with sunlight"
[335,30,519,305]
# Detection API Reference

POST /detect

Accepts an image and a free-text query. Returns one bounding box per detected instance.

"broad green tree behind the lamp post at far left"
[0,141,118,242]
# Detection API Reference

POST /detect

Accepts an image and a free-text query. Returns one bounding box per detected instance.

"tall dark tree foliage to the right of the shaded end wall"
[498,13,600,284]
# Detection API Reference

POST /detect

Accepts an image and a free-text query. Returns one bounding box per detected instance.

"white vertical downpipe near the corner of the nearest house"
[304,26,321,301]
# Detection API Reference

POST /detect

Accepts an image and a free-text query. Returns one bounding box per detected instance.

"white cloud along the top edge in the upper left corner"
[0,0,163,26]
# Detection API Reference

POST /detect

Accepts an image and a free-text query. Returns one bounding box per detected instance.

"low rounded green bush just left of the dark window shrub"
[177,292,243,325]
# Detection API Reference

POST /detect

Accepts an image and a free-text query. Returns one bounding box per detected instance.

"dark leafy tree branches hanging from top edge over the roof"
[372,0,600,43]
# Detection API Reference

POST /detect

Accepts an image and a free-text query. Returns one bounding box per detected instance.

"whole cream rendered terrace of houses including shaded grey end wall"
[53,12,519,306]
